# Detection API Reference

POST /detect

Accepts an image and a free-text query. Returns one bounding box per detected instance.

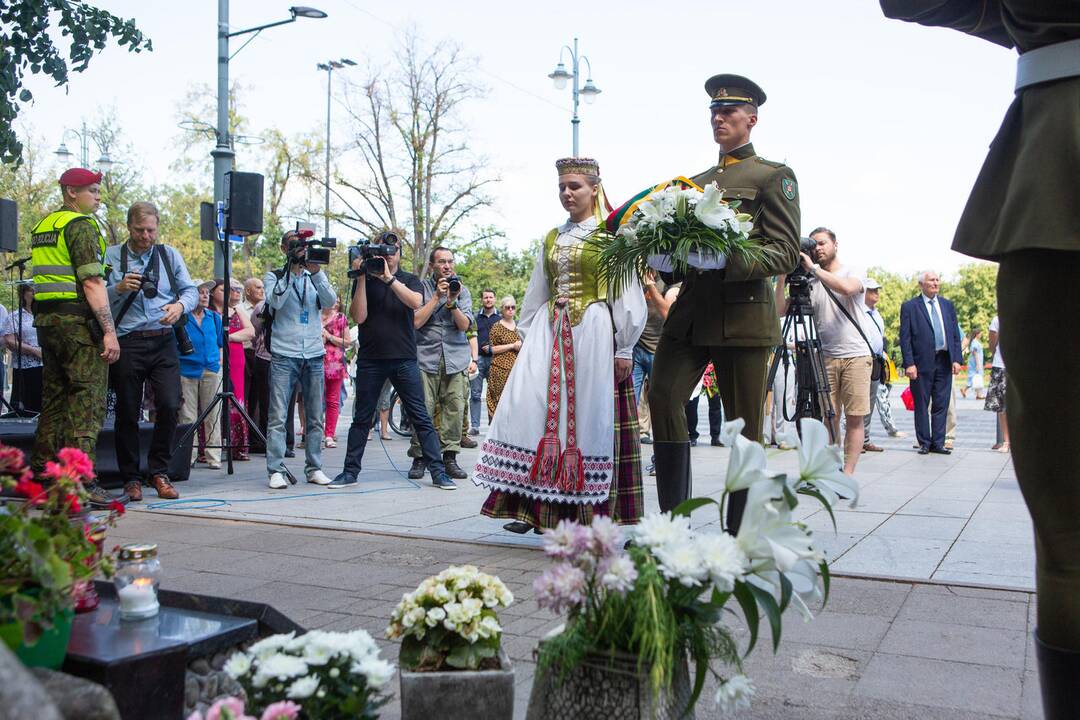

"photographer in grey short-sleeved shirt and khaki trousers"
[408,247,476,480]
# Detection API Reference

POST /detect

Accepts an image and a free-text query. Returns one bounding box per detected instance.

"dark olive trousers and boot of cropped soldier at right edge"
[998,250,1080,720]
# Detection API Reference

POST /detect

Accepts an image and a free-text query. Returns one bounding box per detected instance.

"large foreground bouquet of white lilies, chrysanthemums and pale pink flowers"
[535,419,859,712]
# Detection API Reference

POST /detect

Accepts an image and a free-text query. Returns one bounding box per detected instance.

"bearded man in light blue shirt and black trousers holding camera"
[105,202,199,501]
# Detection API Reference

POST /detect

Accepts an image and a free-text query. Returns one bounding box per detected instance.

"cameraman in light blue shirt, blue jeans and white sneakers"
[262,231,337,490]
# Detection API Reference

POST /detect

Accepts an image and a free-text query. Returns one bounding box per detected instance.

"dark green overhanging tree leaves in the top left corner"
[0,0,153,163]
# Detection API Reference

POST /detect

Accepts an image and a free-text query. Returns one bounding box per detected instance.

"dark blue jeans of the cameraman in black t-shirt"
[345,358,446,479]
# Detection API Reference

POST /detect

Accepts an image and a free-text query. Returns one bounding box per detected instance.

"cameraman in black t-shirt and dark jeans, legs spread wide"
[327,231,457,490]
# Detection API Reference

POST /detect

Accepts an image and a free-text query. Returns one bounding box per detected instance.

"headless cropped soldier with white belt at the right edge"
[881,0,1080,720]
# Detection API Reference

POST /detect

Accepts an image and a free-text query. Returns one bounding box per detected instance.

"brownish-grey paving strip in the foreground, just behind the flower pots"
[108,513,1042,720]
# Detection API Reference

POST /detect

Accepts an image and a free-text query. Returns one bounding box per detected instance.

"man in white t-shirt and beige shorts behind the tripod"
[777,228,874,475]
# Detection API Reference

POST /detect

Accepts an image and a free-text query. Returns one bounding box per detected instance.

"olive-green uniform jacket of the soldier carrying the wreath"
[663,145,799,348]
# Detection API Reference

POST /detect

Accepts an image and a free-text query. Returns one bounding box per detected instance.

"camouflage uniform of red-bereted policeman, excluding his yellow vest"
[30,209,109,473]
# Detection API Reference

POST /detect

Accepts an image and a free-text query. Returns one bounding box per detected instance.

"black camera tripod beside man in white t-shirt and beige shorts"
[766,279,836,443]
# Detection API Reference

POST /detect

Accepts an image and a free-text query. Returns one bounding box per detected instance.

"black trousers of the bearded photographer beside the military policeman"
[109,328,180,483]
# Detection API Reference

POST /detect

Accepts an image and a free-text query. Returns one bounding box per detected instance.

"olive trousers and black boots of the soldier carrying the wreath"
[649,335,770,534]
